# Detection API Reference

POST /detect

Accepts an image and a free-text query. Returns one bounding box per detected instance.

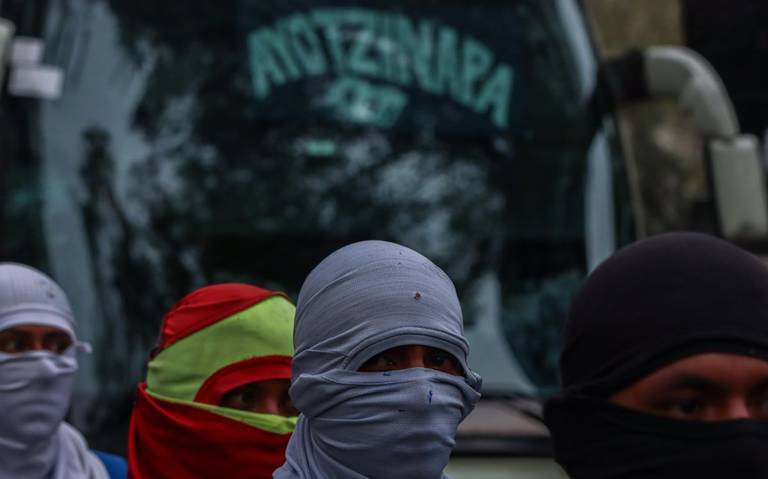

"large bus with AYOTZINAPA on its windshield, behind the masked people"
[0,0,768,479]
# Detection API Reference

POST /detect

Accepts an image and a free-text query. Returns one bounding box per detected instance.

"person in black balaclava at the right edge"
[545,233,768,479]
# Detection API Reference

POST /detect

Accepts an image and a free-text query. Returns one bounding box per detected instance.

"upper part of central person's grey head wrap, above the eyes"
[293,241,477,382]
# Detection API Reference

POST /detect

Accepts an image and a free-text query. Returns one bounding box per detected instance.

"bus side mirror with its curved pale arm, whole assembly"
[605,46,768,241]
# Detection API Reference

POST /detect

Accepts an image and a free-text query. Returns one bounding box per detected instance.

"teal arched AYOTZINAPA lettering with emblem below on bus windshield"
[247,8,514,130]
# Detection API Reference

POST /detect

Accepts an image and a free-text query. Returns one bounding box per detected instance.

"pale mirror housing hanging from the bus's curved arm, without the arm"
[707,135,768,241]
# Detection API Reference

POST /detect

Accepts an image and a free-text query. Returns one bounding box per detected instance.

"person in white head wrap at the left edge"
[0,263,109,479]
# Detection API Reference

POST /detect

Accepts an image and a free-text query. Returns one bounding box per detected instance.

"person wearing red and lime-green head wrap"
[128,283,298,479]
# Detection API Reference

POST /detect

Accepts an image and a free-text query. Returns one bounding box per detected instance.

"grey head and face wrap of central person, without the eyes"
[274,241,481,479]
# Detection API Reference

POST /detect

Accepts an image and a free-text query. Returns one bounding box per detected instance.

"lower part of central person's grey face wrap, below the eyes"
[278,369,480,478]
